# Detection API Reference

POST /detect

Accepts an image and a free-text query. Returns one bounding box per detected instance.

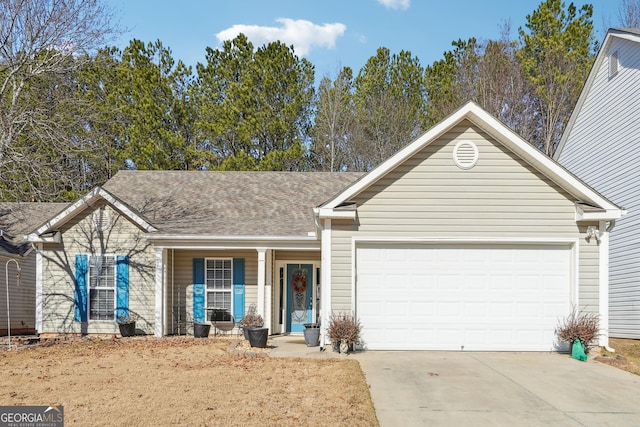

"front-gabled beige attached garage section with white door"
[315,103,624,351]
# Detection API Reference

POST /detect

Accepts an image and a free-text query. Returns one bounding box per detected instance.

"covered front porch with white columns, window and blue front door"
[154,239,322,337]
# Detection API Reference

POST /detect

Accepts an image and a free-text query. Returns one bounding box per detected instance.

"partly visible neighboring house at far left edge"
[0,203,66,335]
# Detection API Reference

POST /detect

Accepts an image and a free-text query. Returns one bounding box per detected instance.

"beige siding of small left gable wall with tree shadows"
[42,204,155,334]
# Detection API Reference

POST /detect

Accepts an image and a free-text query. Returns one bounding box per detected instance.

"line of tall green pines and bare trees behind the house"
[0,0,636,201]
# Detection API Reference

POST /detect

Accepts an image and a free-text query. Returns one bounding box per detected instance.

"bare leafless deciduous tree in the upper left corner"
[0,0,114,200]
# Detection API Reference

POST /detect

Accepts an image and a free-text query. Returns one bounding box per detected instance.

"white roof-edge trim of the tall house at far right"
[553,28,640,160]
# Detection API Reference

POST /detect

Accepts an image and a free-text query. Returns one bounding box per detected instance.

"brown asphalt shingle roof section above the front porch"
[103,170,364,237]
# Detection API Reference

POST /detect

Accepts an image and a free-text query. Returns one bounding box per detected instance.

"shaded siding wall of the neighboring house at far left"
[0,251,36,335]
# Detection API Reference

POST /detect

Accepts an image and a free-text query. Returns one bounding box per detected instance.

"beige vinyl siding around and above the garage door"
[332,121,598,311]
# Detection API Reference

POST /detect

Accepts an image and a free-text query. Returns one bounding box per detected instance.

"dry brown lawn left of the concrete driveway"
[0,338,378,426]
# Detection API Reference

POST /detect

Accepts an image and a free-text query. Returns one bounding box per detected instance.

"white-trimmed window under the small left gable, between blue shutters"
[87,255,116,321]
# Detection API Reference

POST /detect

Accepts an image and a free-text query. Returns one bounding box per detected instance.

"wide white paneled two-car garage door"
[356,245,571,351]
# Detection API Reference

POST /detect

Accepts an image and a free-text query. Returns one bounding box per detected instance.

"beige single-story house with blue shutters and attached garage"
[28,103,623,351]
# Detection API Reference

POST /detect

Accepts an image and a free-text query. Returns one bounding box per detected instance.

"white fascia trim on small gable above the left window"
[27,187,156,243]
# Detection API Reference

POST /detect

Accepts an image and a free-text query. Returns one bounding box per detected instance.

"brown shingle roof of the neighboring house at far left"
[0,202,68,255]
